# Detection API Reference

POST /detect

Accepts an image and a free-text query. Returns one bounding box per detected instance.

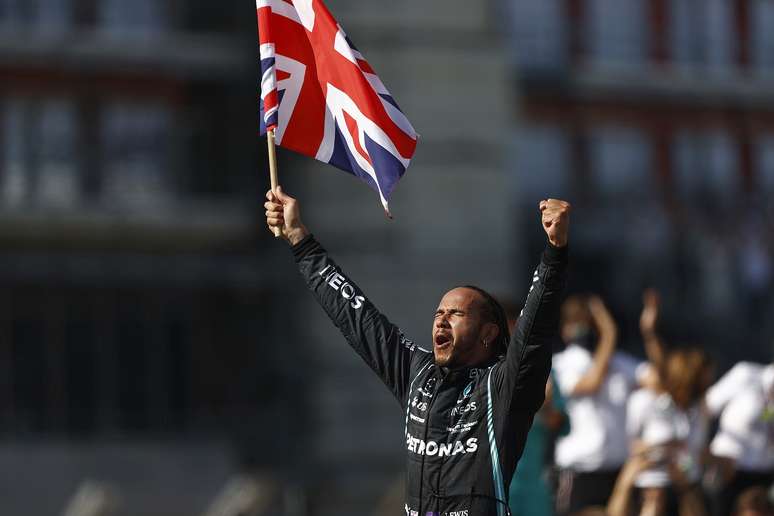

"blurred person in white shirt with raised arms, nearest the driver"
[553,296,647,514]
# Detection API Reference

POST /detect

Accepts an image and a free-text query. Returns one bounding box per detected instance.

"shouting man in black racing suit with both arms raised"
[265,187,570,516]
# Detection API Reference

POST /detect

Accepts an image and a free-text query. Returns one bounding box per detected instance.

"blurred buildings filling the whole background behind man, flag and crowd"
[0,0,774,516]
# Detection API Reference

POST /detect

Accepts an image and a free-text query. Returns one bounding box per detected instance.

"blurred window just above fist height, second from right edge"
[673,130,741,200]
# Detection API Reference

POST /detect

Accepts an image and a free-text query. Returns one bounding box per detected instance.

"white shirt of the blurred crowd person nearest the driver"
[553,343,647,472]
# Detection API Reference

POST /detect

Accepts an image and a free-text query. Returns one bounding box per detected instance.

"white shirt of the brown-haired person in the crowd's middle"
[626,389,709,487]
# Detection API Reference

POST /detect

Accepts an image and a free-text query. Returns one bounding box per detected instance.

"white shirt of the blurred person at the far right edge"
[705,362,774,472]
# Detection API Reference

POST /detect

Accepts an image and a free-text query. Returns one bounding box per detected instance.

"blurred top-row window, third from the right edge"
[586,0,648,63]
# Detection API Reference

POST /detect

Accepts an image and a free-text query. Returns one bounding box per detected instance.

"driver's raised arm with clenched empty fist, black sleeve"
[498,199,570,413]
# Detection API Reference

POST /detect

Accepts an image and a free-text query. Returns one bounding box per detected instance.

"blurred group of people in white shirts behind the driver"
[510,290,774,516]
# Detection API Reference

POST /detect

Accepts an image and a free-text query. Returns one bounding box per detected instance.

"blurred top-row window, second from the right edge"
[669,0,735,72]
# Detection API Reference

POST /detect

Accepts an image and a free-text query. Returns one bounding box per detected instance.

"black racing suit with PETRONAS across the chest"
[293,236,567,516]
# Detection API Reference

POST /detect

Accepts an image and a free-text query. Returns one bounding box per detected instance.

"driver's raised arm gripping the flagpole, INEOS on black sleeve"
[265,187,424,404]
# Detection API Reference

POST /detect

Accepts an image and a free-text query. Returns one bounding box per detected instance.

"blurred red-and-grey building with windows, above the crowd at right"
[503,0,774,364]
